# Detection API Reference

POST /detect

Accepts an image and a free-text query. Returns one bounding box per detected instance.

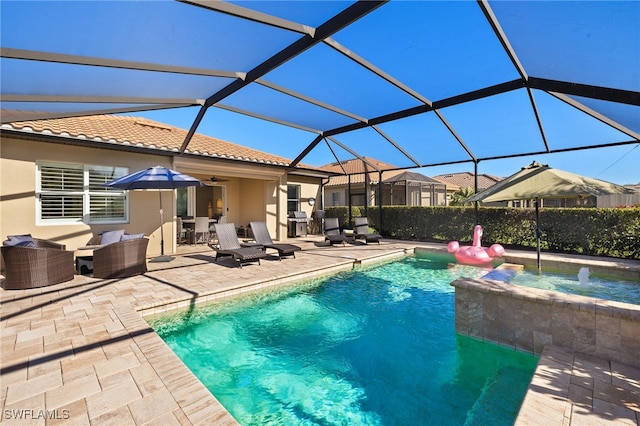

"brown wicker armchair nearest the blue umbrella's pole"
[93,238,149,278]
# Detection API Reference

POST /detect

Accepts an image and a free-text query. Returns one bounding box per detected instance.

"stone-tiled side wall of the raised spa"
[451,278,640,367]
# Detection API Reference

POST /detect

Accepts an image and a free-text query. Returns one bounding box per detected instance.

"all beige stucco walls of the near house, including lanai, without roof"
[0,136,321,269]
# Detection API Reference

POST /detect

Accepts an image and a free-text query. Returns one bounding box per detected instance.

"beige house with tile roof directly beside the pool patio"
[0,115,328,256]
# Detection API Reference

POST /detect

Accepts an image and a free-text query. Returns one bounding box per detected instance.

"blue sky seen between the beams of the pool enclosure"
[5,0,640,184]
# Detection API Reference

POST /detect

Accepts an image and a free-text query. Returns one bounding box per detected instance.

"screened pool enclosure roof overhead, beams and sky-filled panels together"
[0,0,640,173]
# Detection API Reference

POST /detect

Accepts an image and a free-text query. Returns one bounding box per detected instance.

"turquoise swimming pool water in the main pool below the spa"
[150,257,538,425]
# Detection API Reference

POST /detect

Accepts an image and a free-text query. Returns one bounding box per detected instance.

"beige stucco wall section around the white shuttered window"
[0,137,175,255]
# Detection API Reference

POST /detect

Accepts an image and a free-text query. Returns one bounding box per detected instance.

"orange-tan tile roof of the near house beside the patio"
[2,115,304,168]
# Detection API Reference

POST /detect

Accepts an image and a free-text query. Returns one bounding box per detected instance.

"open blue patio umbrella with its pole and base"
[104,166,205,262]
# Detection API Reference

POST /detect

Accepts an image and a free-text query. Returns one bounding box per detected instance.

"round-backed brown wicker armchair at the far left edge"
[0,238,75,290]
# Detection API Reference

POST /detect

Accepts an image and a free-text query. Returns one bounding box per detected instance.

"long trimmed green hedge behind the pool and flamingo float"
[326,206,640,259]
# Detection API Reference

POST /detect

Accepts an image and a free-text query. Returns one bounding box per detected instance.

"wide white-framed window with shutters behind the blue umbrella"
[36,161,129,225]
